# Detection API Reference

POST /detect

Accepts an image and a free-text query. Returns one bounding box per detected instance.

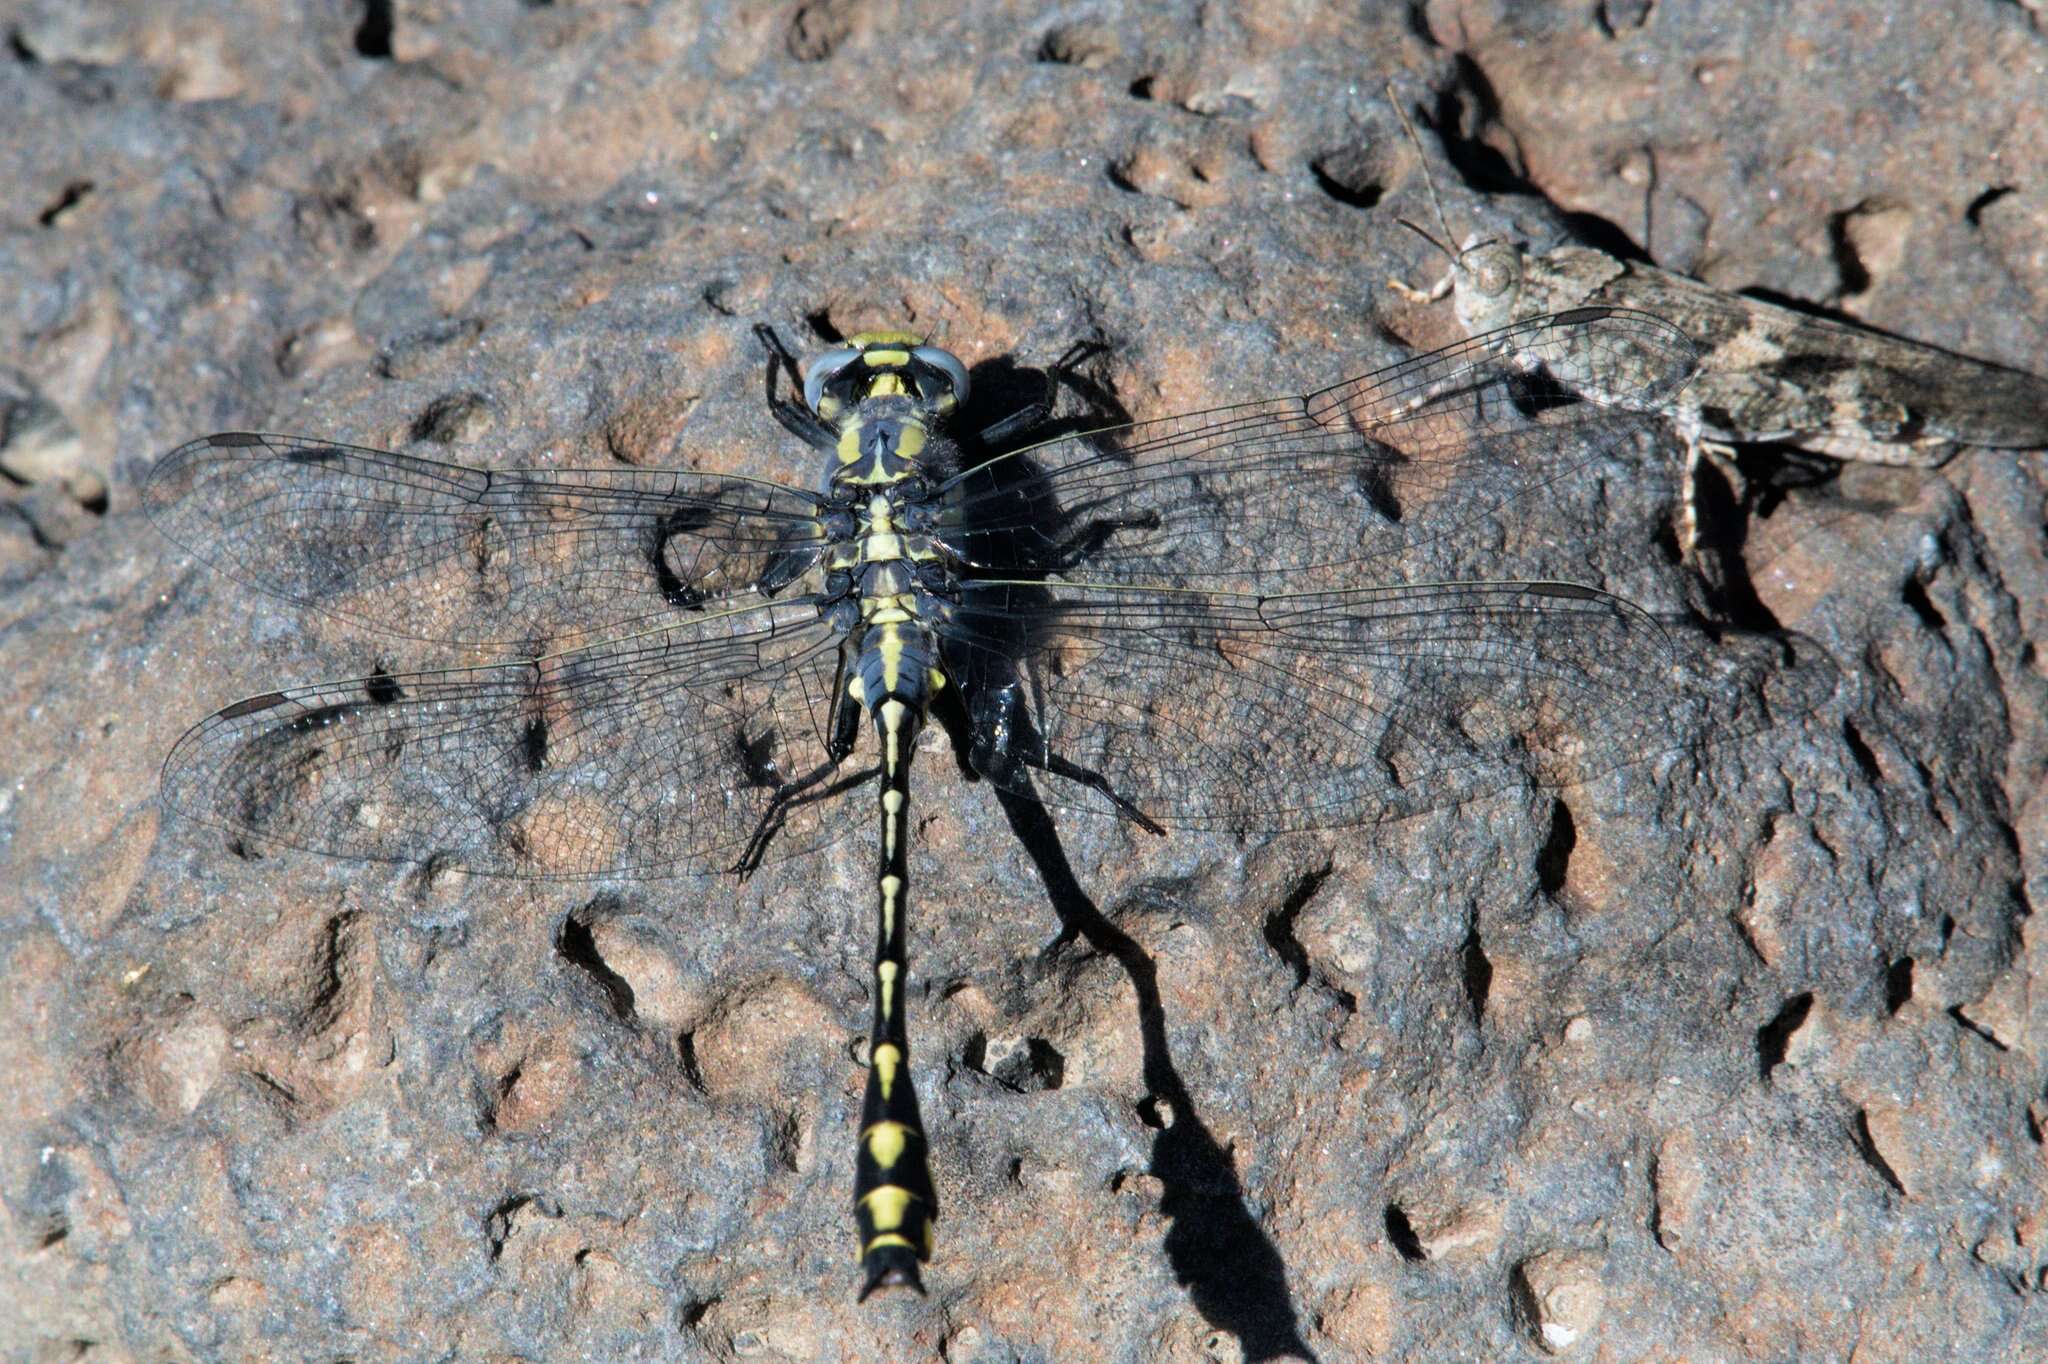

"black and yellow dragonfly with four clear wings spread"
[143,307,1696,1298]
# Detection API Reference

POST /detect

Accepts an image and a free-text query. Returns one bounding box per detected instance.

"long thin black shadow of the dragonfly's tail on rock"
[995,788,1317,1360]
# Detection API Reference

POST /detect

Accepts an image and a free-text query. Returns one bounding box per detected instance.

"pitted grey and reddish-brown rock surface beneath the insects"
[0,0,2048,1362]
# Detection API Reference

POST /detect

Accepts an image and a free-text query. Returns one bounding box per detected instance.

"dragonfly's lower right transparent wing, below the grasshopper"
[954,584,1671,829]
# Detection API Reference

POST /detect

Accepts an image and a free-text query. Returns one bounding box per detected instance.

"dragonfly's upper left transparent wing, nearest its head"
[143,432,821,653]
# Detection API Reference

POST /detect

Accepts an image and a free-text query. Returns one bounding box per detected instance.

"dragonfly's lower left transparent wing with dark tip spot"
[164,606,856,879]
